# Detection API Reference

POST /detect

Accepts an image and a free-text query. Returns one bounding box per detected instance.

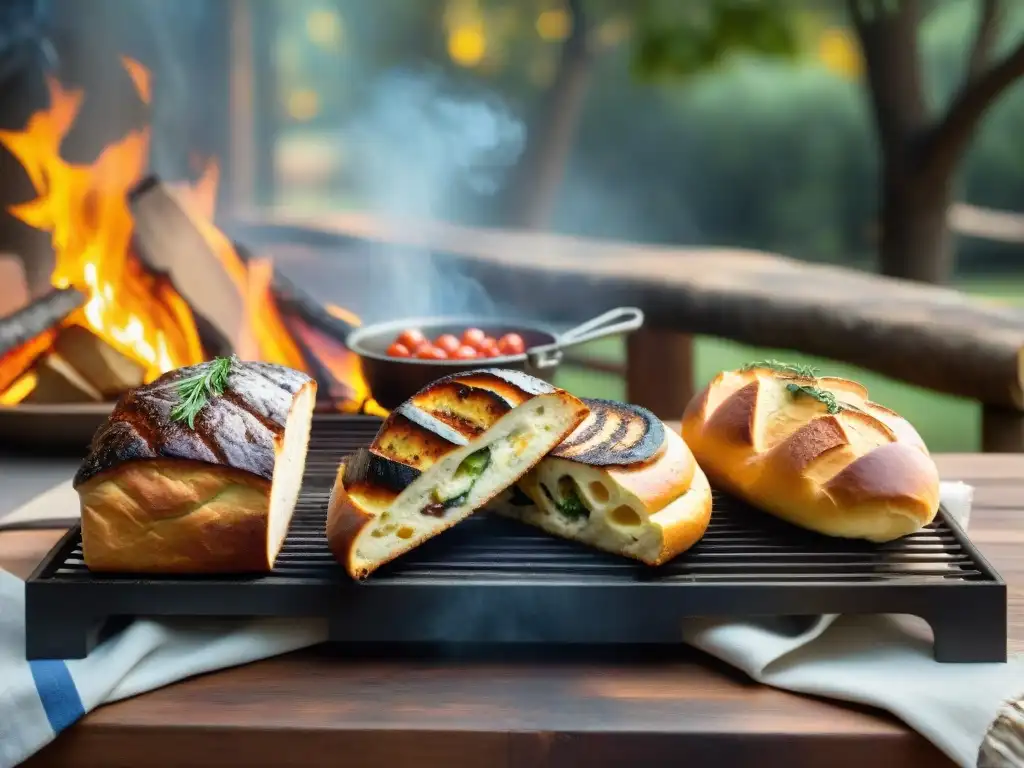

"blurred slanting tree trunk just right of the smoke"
[501,2,592,229]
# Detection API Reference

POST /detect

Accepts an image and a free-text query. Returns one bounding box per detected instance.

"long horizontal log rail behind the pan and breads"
[231,214,1024,411]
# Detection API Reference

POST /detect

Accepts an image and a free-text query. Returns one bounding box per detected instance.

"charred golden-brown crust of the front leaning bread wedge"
[327,369,588,579]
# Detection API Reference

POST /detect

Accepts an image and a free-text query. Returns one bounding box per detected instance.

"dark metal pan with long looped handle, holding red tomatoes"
[346,307,643,410]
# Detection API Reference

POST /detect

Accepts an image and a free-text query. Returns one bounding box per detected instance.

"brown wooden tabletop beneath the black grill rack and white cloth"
[0,455,1024,768]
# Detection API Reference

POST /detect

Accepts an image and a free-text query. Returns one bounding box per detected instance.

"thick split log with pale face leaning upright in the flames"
[128,176,246,349]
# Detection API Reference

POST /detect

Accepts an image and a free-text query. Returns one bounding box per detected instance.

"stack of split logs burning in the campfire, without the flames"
[0,177,370,413]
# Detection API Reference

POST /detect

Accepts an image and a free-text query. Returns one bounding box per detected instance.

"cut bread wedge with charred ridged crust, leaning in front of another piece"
[327,370,588,579]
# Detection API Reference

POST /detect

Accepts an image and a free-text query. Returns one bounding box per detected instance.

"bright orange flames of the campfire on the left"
[0,58,368,410]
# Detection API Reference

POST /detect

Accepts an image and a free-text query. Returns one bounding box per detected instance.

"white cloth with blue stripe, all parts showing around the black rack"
[0,482,1024,768]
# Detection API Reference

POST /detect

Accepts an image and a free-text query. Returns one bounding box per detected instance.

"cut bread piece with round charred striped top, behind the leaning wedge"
[489,399,712,565]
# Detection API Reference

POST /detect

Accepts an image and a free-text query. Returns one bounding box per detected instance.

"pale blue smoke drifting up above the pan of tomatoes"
[342,69,525,316]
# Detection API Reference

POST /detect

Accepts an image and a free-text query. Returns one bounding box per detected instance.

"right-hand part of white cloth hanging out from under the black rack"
[684,482,1024,766]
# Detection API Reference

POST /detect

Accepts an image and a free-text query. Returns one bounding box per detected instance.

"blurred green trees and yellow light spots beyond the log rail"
[266,0,1024,282]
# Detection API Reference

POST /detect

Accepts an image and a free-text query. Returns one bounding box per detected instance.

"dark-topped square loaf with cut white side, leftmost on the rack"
[74,360,316,573]
